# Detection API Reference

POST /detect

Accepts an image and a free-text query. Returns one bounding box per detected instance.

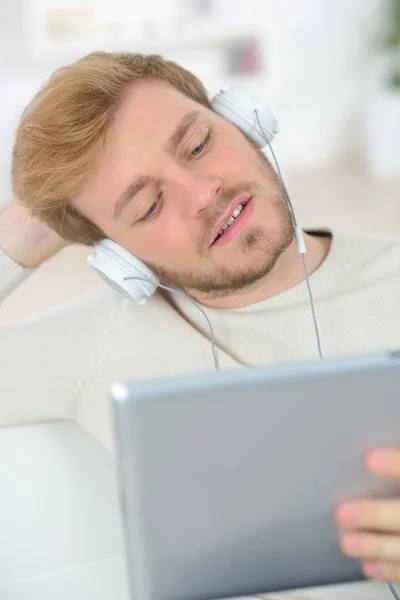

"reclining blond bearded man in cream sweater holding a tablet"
[0,53,400,580]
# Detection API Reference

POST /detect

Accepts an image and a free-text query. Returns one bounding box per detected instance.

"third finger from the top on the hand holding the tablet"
[340,533,400,563]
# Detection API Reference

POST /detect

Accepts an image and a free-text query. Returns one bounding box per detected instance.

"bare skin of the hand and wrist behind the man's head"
[0,202,68,267]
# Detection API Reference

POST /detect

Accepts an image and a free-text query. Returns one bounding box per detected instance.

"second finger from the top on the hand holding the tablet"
[335,499,400,532]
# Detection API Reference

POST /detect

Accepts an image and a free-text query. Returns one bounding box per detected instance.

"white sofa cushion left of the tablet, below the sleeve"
[0,421,128,600]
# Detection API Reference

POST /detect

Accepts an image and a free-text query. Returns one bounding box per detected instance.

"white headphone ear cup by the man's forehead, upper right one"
[211,88,278,148]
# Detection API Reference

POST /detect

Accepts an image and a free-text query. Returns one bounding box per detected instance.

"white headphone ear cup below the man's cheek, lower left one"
[88,239,160,304]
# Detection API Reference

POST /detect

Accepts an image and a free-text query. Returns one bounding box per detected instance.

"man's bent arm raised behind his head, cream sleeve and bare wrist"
[0,203,111,426]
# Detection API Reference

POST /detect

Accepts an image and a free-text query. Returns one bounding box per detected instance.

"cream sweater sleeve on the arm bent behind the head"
[0,248,120,426]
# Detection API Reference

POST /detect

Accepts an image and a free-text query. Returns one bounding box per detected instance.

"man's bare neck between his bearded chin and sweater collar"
[191,233,331,309]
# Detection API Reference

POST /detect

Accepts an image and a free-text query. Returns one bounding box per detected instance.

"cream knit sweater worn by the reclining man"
[0,232,400,450]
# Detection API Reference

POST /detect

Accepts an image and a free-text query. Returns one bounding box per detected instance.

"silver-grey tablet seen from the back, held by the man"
[111,354,400,600]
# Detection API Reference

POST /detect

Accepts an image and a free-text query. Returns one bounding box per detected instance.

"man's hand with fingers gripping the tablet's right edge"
[335,450,400,581]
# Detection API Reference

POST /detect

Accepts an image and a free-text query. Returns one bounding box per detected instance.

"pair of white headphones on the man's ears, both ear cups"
[88,88,278,304]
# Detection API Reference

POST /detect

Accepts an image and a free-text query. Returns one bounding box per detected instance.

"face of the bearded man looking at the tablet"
[74,81,293,296]
